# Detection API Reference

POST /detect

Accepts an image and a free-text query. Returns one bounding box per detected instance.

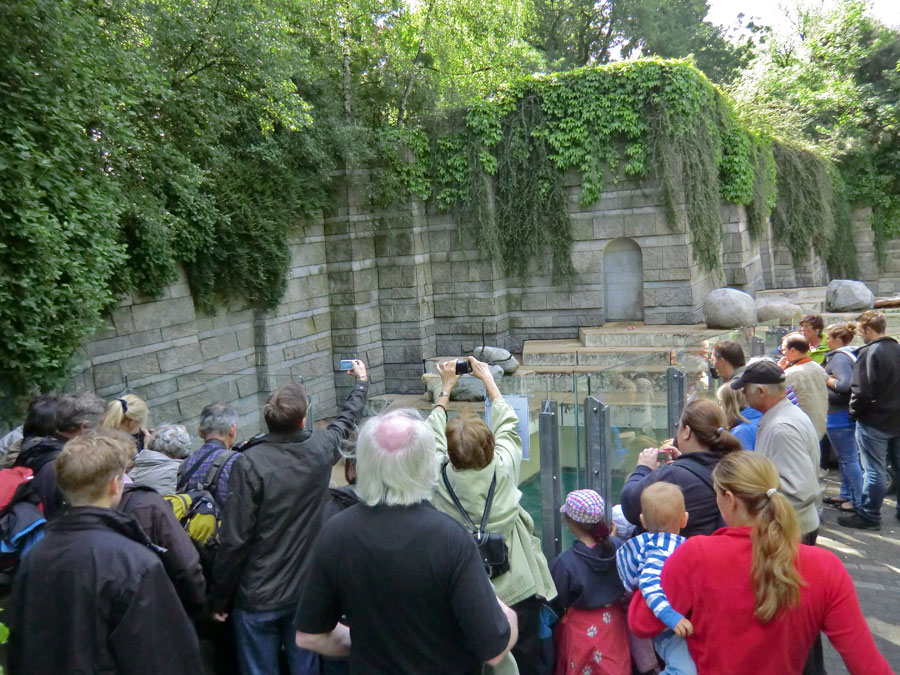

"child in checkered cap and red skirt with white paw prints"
[550,490,631,675]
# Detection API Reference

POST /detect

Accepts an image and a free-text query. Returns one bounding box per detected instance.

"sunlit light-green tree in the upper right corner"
[733,0,900,245]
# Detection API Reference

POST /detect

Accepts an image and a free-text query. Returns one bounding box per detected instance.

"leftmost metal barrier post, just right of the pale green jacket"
[538,401,562,563]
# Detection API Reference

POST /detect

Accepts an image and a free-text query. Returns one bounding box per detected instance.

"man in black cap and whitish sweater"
[731,359,820,545]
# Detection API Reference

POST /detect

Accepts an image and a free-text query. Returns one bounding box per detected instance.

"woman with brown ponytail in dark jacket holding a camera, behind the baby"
[621,399,741,537]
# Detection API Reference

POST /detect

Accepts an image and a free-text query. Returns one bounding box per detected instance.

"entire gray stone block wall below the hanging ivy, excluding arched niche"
[72,172,884,422]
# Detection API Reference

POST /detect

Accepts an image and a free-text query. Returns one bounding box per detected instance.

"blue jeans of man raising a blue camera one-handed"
[232,609,319,675]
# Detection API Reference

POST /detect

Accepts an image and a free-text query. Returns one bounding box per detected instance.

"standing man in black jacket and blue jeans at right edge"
[838,310,900,530]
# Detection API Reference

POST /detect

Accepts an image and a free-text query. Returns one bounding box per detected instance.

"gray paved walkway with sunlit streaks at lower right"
[817,471,900,675]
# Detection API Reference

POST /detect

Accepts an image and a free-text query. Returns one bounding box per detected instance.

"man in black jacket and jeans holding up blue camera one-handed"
[211,361,369,675]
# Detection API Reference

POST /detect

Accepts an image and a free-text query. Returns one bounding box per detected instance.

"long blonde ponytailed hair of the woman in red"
[713,450,805,623]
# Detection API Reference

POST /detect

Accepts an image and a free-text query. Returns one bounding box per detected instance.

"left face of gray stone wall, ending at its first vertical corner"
[71,222,335,437]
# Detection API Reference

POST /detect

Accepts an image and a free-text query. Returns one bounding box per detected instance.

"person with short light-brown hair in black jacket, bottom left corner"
[8,429,203,675]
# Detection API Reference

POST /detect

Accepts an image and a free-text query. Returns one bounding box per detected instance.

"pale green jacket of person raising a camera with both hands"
[428,399,556,605]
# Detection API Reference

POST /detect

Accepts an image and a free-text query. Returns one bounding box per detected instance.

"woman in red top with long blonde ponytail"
[628,450,892,675]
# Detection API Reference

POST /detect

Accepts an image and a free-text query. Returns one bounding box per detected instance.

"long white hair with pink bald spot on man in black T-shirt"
[356,408,437,506]
